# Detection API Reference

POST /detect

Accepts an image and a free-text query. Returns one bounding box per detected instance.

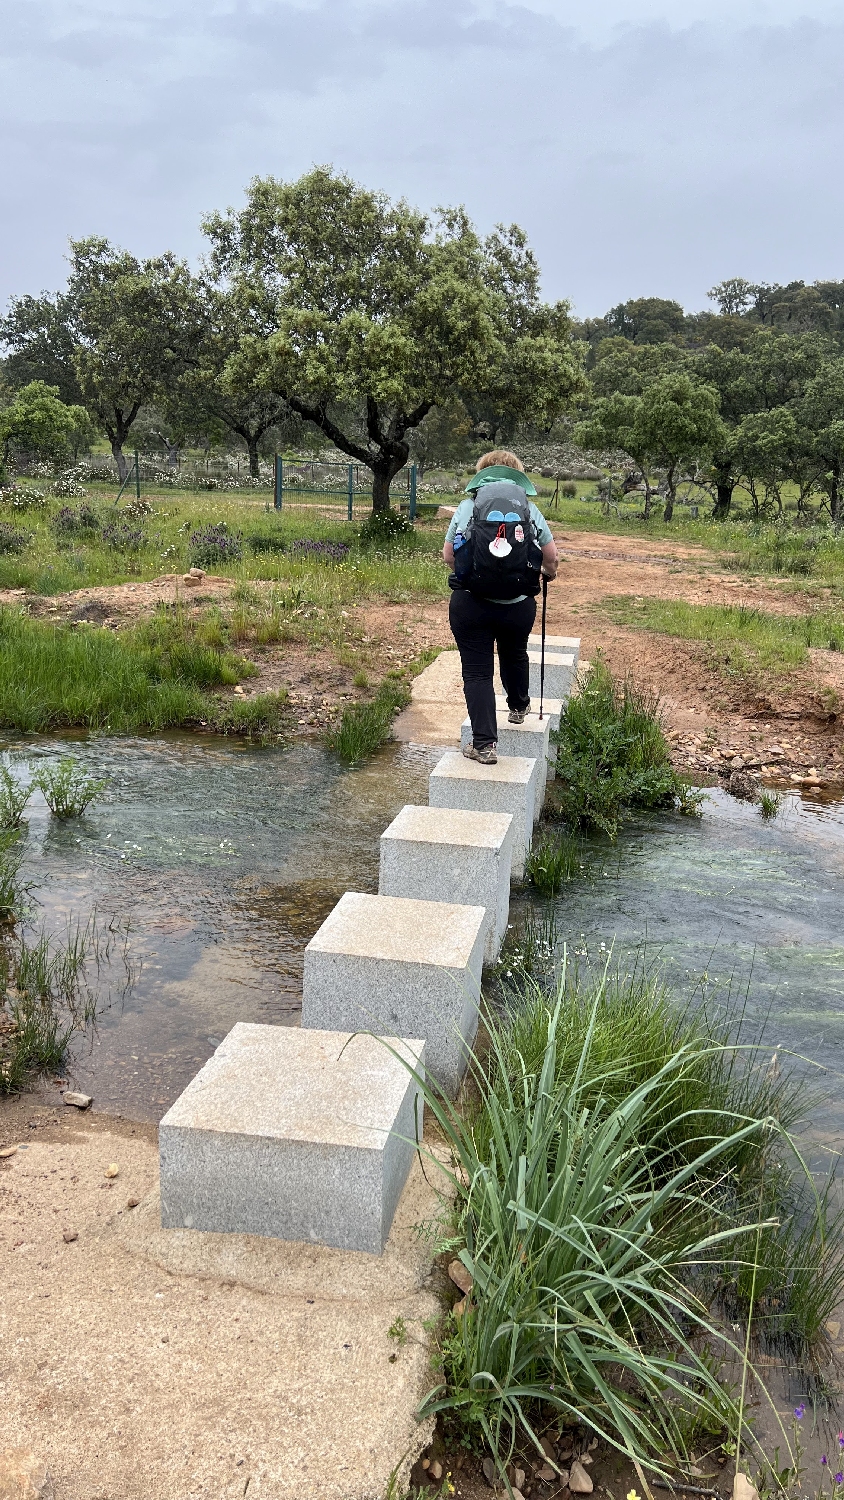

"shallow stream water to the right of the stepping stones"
[513,788,844,1149]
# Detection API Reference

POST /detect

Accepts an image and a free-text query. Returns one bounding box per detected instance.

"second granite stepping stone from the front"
[301,891,486,1094]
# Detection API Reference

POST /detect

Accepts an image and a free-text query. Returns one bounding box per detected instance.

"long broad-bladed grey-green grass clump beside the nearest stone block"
[423,977,778,1469]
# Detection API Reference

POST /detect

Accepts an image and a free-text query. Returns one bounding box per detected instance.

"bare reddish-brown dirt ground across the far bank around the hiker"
[0,528,844,788]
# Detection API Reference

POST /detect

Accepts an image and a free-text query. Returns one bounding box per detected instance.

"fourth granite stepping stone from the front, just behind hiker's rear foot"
[427,750,538,881]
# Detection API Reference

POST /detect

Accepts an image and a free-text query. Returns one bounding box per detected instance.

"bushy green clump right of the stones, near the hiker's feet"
[549,657,702,839]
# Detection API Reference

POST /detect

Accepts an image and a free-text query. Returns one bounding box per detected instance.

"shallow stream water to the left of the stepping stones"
[6,735,442,1119]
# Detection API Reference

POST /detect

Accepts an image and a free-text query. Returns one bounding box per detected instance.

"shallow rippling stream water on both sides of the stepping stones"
[9,735,844,1146]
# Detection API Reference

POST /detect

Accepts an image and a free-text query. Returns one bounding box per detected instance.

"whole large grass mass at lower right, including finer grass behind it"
[424,960,844,1475]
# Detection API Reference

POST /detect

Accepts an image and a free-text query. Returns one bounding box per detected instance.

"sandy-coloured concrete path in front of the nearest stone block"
[0,1116,439,1500]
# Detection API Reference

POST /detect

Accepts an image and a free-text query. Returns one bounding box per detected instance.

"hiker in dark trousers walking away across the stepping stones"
[442,449,558,765]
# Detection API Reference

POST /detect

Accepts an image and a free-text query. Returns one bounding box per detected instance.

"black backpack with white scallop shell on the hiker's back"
[448,479,543,599]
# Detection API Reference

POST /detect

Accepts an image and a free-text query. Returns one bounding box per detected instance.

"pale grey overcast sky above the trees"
[0,0,844,317]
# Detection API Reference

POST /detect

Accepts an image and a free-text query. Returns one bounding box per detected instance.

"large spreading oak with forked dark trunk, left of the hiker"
[204,168,583,510]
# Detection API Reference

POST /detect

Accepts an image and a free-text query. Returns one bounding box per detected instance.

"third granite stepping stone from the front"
[378,806,513,963]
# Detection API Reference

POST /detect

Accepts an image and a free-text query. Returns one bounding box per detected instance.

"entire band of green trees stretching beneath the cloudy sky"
[0,168,844,525]
